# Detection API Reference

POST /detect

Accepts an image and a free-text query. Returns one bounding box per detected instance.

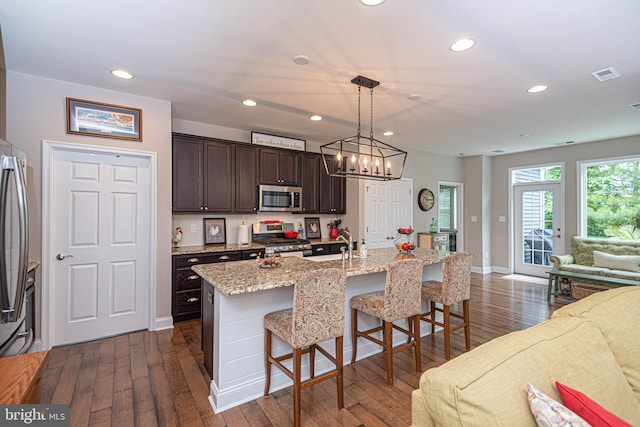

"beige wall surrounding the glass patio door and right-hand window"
[487,136,640,271]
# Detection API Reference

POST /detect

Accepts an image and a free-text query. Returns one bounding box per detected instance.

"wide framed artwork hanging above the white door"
[67,98,142,141]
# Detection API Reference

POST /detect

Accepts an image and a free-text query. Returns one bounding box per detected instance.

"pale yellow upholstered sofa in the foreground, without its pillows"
[412,286,640,427]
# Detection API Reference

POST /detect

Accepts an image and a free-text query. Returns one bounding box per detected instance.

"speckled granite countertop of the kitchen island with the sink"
[191,248,449,295]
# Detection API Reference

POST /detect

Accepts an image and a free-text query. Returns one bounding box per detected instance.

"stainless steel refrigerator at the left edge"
[0,139,33,357]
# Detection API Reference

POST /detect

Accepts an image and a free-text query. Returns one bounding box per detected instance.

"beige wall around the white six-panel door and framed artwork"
[7,71,171,326]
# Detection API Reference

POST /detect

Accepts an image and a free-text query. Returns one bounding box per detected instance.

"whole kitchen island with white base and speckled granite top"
[192,248,448,412]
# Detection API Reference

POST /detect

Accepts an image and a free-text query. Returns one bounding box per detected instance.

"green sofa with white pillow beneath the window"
[550,236,640,282]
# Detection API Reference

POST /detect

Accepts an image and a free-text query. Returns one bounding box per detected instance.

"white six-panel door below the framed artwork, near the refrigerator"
[50,150,152,345]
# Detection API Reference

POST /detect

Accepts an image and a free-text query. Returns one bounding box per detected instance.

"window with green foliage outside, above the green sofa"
[580,158,640,240]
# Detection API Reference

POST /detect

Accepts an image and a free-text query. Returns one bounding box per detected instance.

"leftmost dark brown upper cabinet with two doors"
[173,136,235,212]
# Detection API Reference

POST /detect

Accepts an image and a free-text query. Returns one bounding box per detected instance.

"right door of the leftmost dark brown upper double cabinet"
[204,141,235,212]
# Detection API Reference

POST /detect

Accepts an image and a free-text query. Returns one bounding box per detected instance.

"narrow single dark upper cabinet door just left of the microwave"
[235,145,258,213]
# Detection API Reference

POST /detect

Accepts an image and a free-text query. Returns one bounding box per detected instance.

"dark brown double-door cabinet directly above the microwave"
[259,148,302,187]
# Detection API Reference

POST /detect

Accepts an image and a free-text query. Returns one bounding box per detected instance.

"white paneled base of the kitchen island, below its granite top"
[201,261,442,413]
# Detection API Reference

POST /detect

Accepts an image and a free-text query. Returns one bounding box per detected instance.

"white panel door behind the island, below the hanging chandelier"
[364,178,413,249]
